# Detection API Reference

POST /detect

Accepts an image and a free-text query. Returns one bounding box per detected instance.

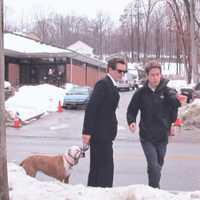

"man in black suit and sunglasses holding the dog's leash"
[82,58,127,187]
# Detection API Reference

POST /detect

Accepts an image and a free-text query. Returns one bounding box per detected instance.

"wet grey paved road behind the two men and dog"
[7,91,200,191]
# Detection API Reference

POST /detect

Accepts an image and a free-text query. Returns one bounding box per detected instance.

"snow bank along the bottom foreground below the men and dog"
[8,163,200,200]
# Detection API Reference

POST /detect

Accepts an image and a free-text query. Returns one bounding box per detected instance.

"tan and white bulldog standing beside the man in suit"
[20,146,88,183]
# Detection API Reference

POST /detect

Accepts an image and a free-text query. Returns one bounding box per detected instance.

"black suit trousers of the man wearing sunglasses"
[88,142,114,187]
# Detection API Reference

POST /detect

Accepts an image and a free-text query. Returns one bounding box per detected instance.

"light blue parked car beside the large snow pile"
[63,86,92,109]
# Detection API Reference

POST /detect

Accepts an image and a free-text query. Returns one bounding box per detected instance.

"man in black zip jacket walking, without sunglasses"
[127,60,180,188]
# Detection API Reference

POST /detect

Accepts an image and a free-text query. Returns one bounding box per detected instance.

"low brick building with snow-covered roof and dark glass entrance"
[4,33,106,86]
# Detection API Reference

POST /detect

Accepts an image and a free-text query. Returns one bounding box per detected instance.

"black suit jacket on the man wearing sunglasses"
[83,76,119,143]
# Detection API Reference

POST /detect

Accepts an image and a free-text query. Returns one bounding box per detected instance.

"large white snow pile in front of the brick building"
[5,84,65,121]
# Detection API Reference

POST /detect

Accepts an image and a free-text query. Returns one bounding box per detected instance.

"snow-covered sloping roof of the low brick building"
[4,33,106,68]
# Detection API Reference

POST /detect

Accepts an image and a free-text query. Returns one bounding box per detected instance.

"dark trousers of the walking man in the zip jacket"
[141,141,167,188]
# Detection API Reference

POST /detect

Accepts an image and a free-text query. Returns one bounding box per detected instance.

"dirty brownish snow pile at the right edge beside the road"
[179,99,200,127]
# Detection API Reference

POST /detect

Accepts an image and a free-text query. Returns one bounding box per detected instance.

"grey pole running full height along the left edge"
[0,0,9,200]
